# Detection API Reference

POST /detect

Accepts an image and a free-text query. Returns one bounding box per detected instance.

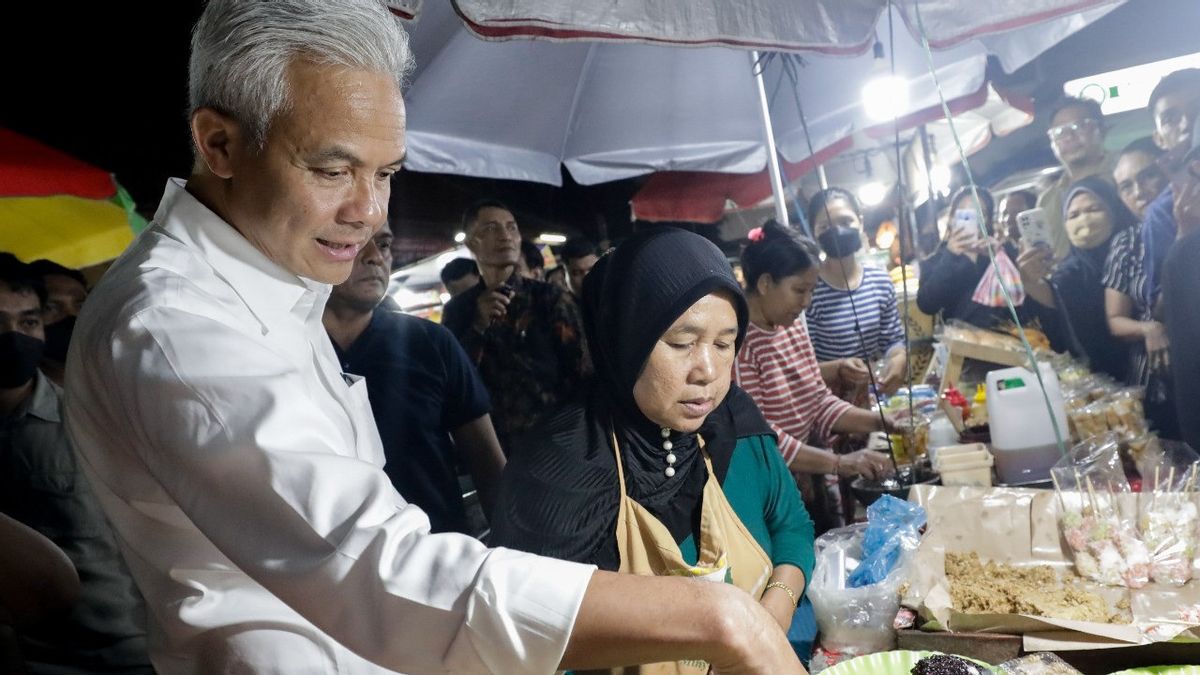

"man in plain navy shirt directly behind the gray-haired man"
[323,225,504,534]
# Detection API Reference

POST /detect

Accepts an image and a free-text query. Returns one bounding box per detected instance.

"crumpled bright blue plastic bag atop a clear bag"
[847,495,925,589]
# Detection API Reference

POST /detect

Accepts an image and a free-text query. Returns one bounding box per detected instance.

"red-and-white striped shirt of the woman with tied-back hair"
[733,319,853,462]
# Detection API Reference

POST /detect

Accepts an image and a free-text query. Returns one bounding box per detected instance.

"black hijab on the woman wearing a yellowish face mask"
[1051,175,1138,380]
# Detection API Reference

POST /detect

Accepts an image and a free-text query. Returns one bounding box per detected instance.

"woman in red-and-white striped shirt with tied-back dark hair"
[733,221,894,531]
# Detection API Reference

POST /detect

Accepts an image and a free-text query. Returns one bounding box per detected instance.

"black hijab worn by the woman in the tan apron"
[491,228,772,569]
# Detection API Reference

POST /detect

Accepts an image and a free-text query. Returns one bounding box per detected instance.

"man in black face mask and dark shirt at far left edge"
[0,253,154,674]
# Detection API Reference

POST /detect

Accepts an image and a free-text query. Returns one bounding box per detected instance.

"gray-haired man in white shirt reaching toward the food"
[66,0,803,674]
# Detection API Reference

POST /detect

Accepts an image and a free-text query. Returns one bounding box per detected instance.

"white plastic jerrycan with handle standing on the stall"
[988,363,1070,485]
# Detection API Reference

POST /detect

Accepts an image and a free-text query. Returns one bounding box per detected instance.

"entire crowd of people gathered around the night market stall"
[0,0,1200,674]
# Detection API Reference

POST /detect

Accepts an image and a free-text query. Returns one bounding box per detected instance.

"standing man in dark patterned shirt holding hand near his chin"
[442,201,589,452]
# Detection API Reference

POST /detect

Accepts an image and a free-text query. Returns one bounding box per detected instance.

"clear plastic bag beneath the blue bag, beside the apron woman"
[808,524,911,658]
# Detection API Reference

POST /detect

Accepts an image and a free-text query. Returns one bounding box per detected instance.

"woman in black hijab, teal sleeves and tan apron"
[491,228,812,674]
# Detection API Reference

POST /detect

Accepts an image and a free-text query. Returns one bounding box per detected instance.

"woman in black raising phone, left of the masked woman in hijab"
[917,185,1025,329]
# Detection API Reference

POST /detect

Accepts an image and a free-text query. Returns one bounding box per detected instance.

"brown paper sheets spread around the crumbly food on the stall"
[904,485,1200,651]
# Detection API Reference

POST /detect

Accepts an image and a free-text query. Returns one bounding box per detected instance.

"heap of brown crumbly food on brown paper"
[946,552,1127,623]
